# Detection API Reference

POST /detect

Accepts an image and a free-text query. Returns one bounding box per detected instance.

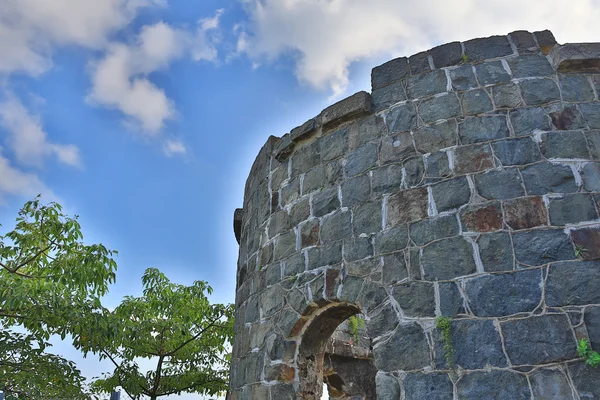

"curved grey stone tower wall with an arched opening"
[230,31,600,400]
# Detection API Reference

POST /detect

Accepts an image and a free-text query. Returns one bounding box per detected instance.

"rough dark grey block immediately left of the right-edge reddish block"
[513,229,575,266]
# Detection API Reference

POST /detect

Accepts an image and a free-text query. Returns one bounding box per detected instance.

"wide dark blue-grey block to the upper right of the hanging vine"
[465,270,542,317]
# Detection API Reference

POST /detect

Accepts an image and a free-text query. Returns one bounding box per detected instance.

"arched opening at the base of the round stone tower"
[298,303,377,400]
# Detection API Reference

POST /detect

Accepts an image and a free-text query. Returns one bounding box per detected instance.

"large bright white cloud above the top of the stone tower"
[238,0,600,94]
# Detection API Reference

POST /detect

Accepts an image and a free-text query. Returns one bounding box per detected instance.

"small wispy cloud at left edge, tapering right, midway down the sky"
[0,95,81,169]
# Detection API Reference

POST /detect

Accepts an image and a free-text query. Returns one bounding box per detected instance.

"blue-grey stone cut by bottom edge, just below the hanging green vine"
[404,373,454,400]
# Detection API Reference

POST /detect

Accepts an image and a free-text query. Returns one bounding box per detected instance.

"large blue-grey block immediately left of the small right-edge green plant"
[501,314,577,365]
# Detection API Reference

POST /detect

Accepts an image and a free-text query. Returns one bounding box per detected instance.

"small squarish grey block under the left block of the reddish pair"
[477,232,515,272]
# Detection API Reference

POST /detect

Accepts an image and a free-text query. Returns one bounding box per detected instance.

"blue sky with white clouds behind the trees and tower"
[0,0,600,398]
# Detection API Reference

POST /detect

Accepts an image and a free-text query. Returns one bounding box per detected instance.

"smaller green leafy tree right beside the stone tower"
[86,268,233,400]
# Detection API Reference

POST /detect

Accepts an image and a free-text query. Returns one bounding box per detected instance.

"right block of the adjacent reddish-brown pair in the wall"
[504,196,548,230]
